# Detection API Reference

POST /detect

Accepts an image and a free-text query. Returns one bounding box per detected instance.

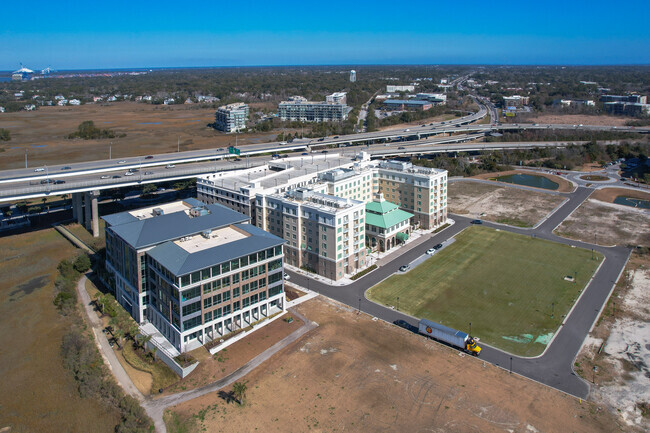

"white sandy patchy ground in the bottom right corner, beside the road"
[576,254,650,431]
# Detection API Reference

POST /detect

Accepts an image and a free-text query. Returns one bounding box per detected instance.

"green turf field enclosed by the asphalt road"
[366,227,602,356]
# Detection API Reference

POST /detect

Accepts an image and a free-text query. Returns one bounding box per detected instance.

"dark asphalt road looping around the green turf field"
[288,188,630,398]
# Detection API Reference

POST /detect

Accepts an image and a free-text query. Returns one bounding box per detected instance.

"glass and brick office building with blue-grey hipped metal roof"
[104,199,284,354]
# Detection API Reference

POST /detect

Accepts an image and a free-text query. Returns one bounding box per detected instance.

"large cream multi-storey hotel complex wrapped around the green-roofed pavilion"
[197,154,447,280]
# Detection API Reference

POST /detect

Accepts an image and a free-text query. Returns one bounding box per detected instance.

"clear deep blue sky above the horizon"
[0,0,650,70]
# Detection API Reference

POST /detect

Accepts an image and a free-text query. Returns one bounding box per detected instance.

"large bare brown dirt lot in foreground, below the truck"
[168,298,621,433]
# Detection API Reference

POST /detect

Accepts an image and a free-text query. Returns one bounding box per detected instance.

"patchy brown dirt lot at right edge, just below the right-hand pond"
[556,198,650,246]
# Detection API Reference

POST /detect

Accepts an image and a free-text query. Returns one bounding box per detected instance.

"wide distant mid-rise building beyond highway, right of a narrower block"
[278,94,351,122]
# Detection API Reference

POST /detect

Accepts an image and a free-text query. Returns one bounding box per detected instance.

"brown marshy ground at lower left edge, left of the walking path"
[0,229,119,433]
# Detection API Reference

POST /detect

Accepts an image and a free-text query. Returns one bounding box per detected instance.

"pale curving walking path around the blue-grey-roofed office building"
[77,275,318,433]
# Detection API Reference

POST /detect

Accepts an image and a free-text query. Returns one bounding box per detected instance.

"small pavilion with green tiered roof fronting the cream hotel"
[366,193,413,252]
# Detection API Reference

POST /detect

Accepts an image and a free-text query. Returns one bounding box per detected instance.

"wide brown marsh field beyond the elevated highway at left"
[0,102,278,169]
